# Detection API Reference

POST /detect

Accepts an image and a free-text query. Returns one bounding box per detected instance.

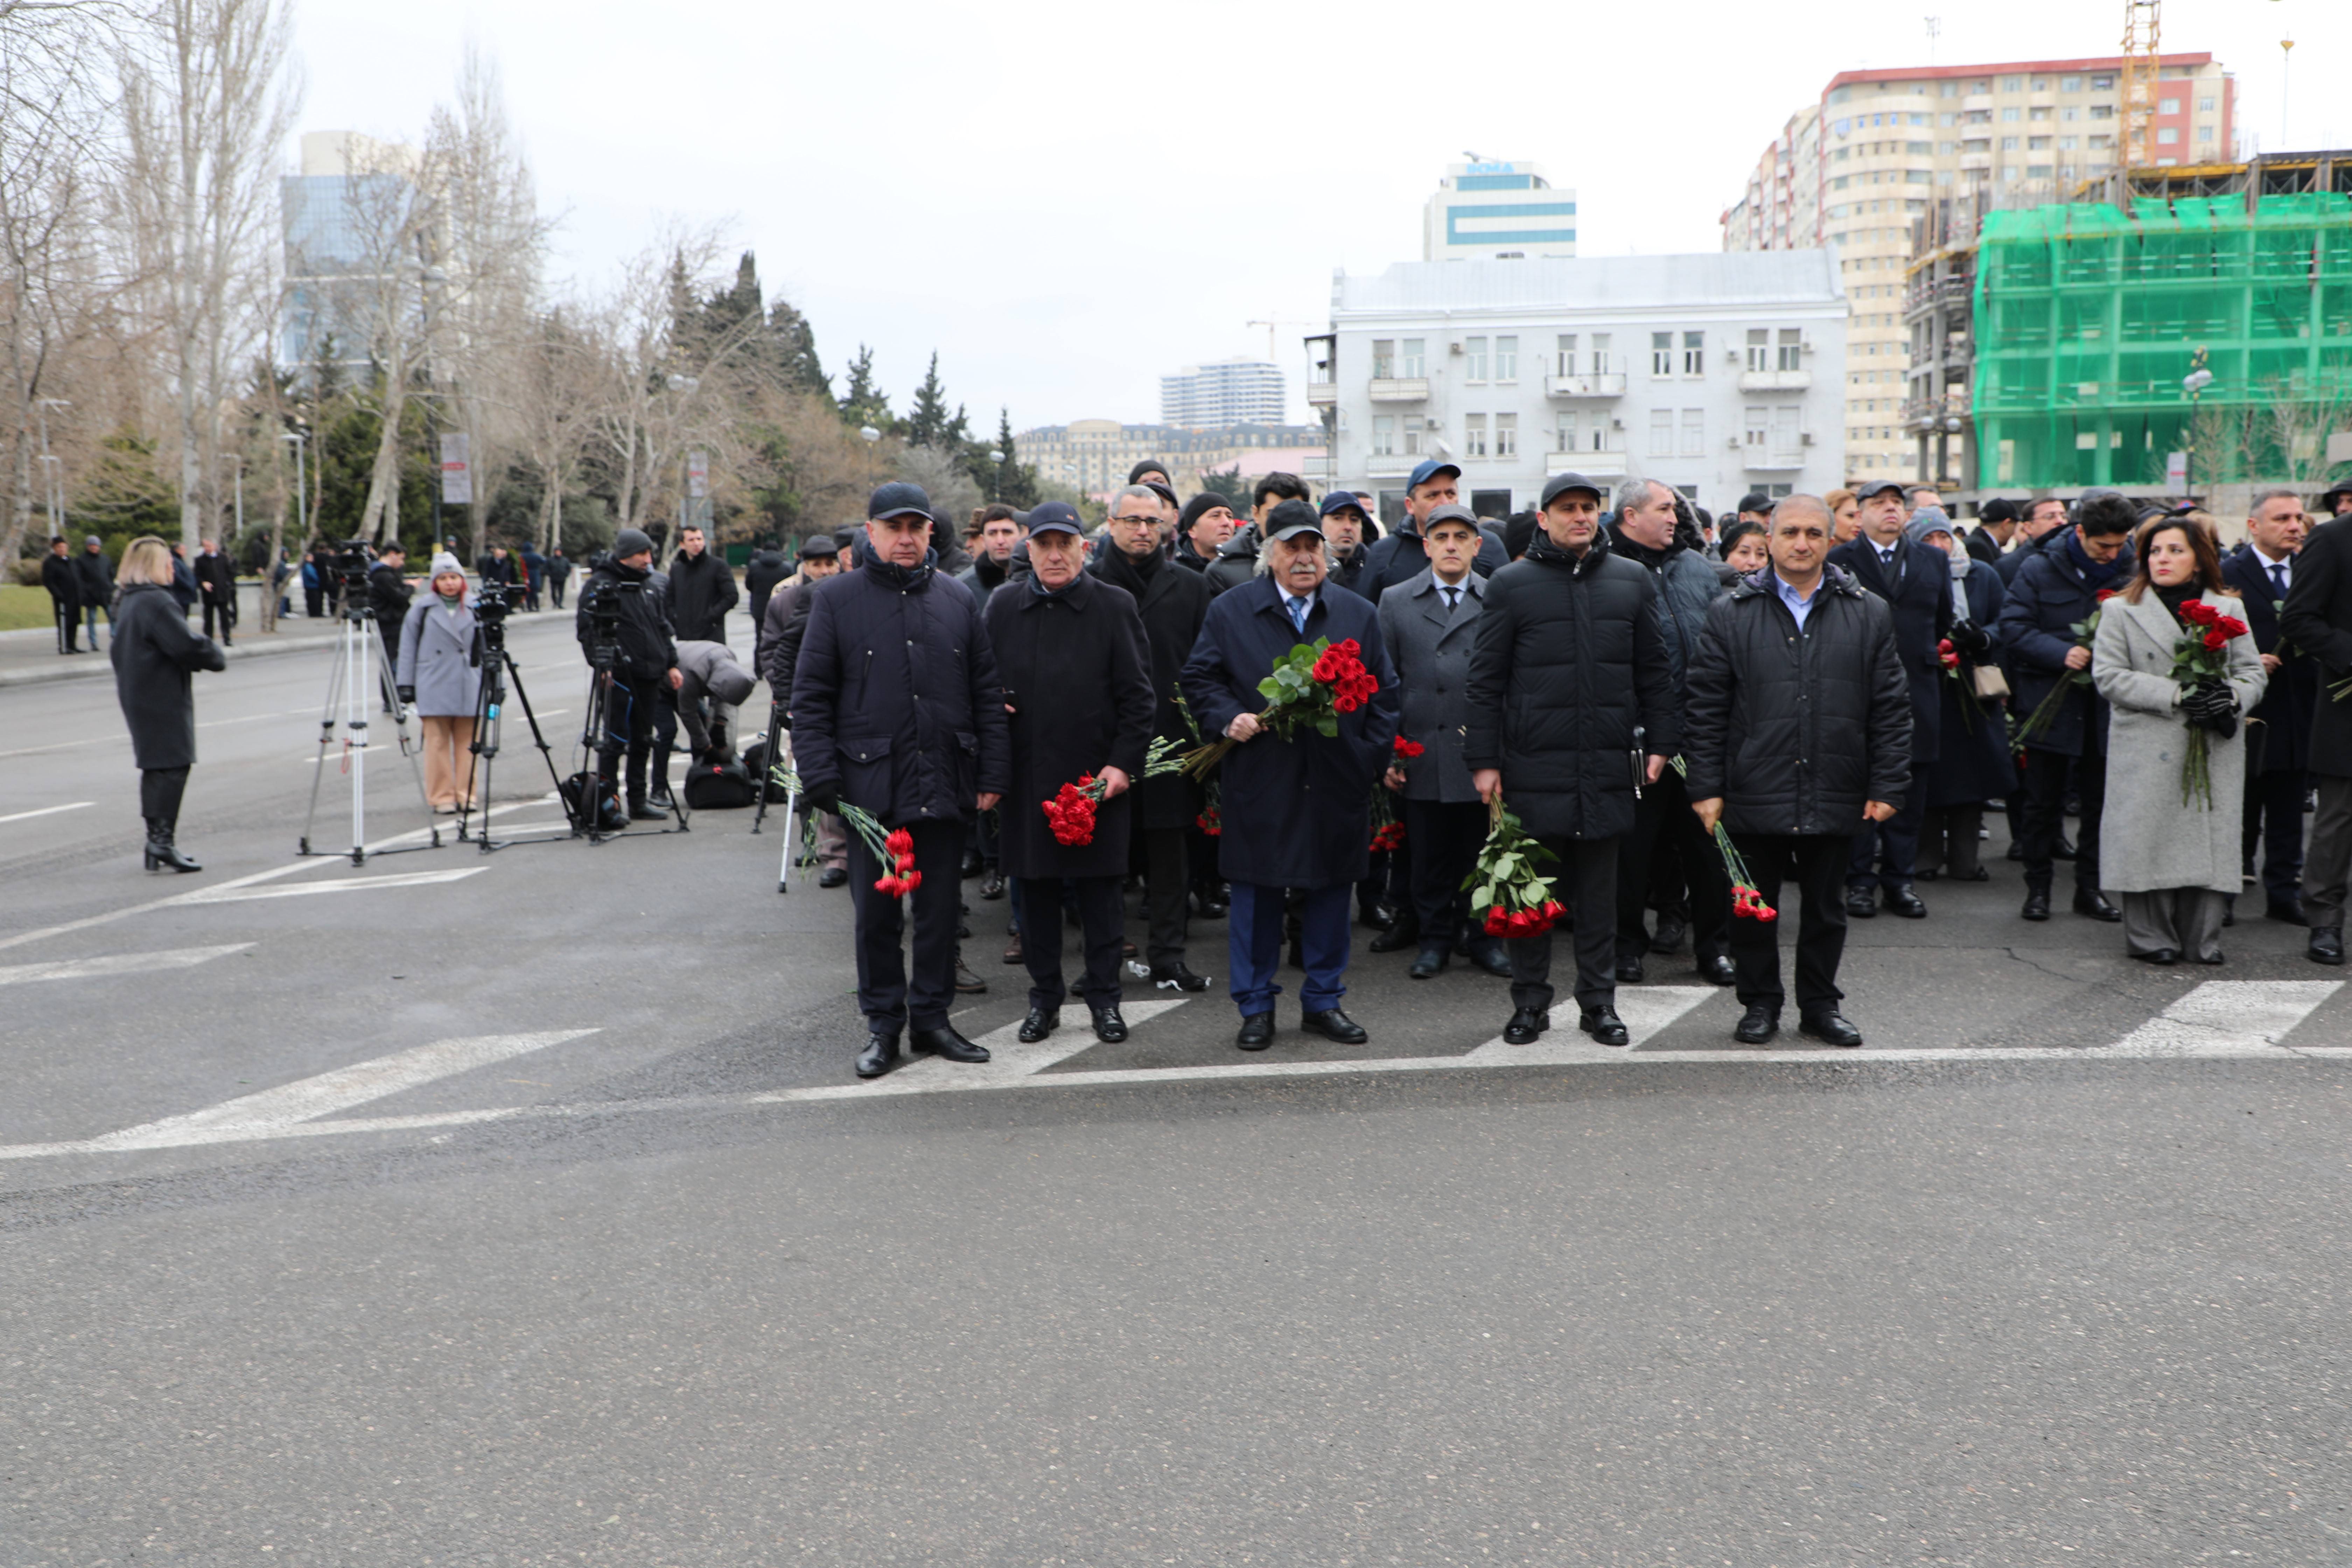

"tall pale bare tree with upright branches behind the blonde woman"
[118,0,299,550]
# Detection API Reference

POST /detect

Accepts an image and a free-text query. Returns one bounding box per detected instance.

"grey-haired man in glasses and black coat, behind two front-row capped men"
[1091,484,1211,992]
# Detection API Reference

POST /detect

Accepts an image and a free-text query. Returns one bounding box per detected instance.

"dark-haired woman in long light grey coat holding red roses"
[2091,517,2265,964]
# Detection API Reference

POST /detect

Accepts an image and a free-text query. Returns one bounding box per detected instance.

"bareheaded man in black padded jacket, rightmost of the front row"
[1684,496,1914,1046]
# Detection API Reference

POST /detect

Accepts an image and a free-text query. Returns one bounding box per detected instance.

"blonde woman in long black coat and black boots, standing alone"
[113,536,228,872]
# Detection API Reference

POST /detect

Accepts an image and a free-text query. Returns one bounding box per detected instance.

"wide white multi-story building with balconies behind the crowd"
[1308,249,1846,522]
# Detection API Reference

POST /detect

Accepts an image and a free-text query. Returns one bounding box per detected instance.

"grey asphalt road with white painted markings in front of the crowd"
[0,606,2352,1568]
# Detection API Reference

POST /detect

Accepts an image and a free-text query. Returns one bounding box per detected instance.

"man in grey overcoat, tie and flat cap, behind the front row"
[1381,505,1510,980]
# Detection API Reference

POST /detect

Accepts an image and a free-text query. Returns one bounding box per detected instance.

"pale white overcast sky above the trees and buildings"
[303,0,2352,430]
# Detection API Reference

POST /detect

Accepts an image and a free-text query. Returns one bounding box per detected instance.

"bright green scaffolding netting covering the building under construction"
[1971,193,2352,489]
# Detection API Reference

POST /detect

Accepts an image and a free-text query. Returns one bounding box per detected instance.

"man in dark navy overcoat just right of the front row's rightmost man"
[1830,479,1992,919]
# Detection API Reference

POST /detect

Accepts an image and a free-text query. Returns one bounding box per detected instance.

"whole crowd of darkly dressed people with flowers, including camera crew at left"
[87,458,2352,1077]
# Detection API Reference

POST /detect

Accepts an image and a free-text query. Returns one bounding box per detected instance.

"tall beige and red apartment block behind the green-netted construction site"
[1724,54,2237,477]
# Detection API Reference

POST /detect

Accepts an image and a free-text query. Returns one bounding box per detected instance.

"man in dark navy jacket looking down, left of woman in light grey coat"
[2002,489,2138,924]
